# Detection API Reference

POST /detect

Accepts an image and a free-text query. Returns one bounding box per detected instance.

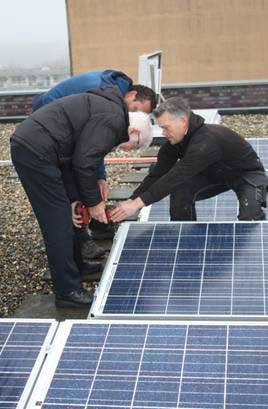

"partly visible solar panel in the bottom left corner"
[0,319,56,409]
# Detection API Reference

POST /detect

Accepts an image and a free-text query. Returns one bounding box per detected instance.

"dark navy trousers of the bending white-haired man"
[11,141,81,293]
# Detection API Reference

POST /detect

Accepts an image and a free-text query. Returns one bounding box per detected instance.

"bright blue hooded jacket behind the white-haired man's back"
[32,70,133,179]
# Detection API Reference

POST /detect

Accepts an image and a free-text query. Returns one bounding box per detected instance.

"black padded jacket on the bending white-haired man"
[11,87,129,206]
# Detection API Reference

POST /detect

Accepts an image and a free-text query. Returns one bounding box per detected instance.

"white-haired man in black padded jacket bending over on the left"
[11,87,153,307]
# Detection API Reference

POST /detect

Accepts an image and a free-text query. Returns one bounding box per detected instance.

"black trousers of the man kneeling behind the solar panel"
[170,175,266,221]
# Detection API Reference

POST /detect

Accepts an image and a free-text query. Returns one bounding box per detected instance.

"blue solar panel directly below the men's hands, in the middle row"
[91,222,268,318]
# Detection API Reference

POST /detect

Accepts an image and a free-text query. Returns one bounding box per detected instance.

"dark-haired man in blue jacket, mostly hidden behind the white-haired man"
[32,70,156,272]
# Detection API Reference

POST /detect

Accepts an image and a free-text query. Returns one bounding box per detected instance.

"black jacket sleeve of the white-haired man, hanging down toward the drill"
[72,114,127,207]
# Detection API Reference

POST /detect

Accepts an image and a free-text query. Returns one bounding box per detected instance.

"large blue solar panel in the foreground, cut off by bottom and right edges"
[28,321,268,409]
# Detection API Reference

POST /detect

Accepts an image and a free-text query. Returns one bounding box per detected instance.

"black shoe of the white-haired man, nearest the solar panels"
[55,288,93,308]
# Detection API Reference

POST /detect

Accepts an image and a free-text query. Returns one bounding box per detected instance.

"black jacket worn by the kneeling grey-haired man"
[131,113,268,206]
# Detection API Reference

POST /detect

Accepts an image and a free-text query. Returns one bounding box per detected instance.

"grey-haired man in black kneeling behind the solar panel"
[112,97,268,222]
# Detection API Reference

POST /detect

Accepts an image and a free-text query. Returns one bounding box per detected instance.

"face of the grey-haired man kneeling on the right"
[157,112,188,145]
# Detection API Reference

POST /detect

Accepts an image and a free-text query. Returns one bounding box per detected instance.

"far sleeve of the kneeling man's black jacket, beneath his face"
[130,143,178,199]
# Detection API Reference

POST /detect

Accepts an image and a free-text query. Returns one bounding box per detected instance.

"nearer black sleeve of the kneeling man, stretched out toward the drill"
[139,135,221,206]
